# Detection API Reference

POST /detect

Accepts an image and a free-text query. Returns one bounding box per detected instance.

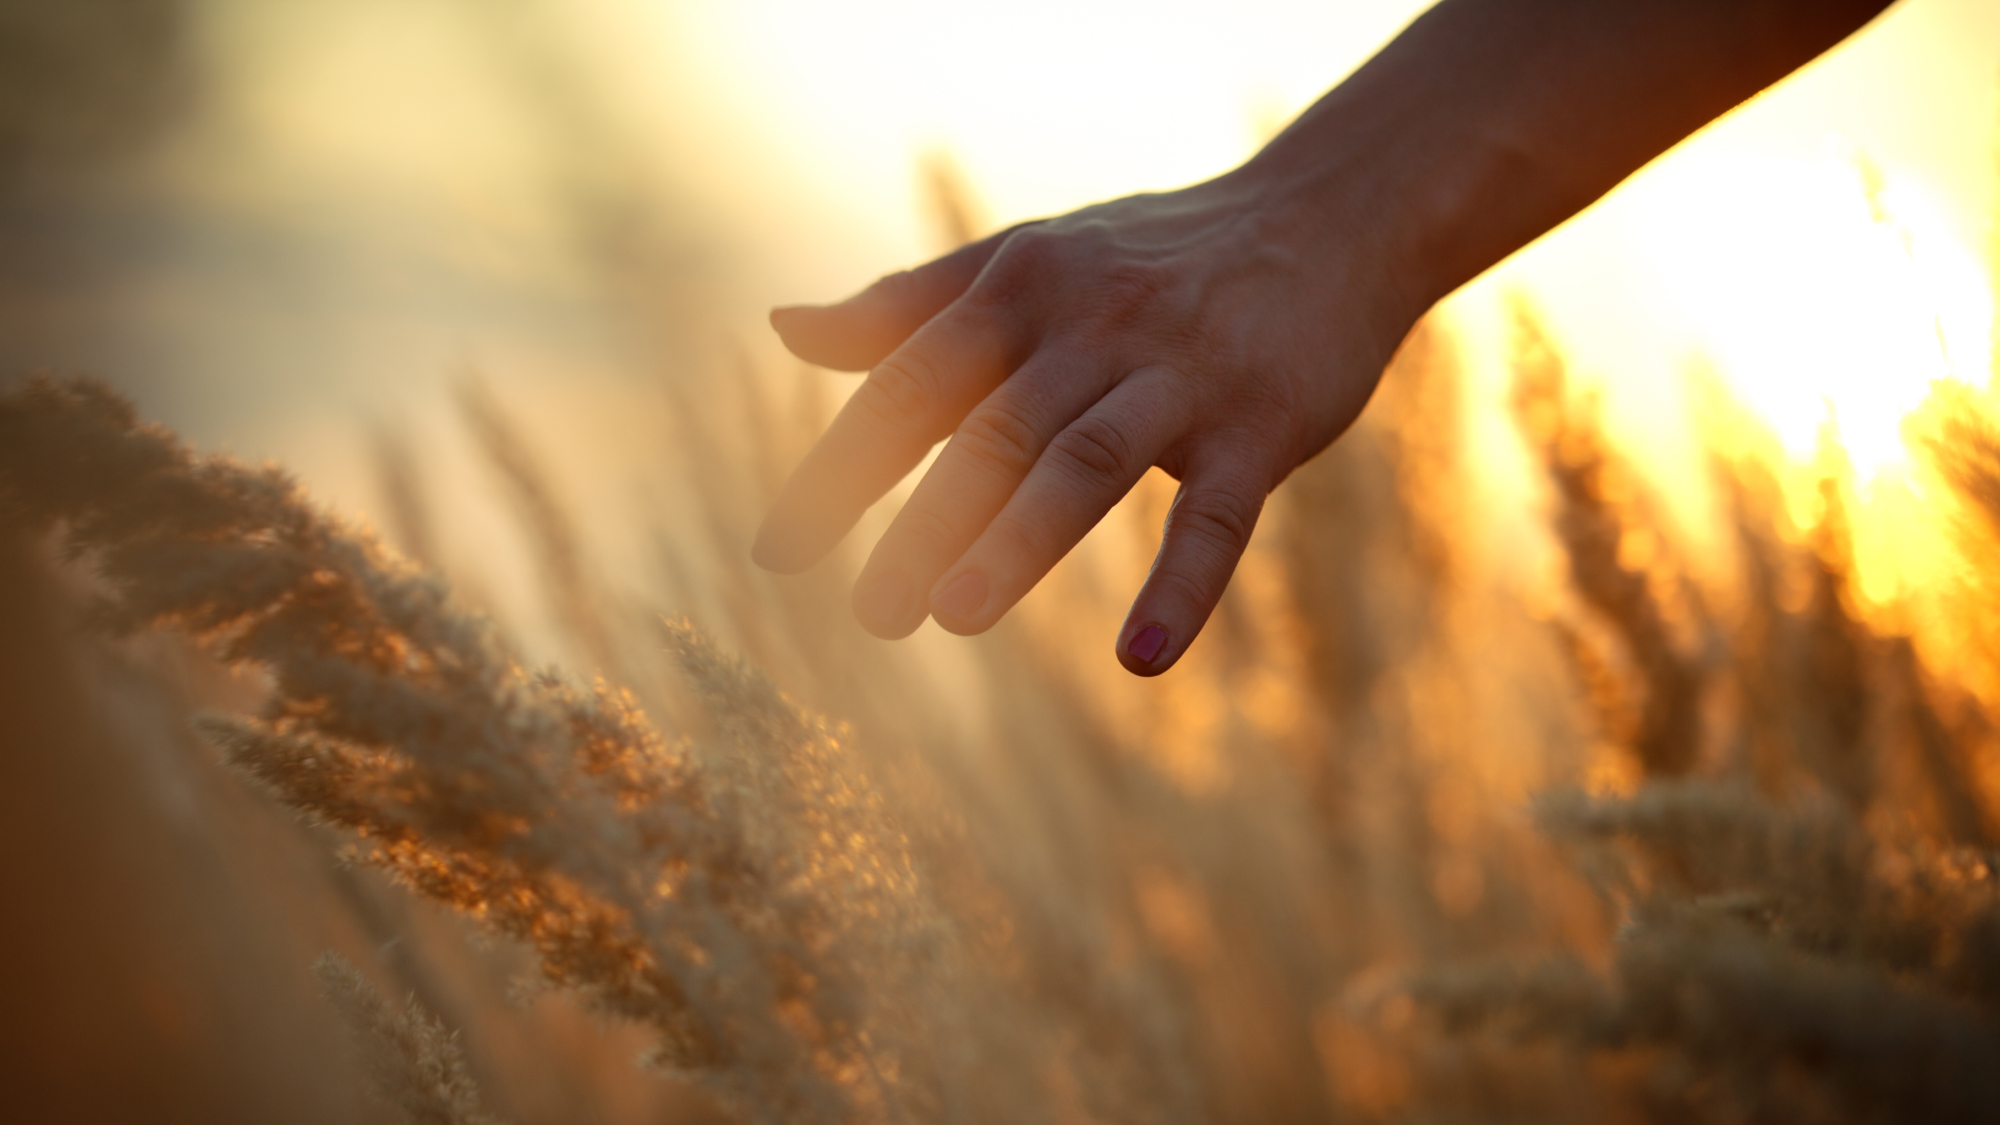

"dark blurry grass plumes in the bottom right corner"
[1414,781,2000,1123]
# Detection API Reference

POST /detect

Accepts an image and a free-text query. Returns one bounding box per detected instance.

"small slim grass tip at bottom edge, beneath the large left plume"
[314,953,500,1125]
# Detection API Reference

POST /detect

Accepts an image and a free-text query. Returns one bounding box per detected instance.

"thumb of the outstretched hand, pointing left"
[770,226,1020,370]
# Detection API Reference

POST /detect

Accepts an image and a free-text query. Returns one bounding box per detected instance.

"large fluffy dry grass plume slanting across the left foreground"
[0,380,930,1123]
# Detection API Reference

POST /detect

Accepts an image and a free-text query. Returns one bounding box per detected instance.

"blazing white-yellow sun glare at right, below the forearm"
[1640,154,1994,478]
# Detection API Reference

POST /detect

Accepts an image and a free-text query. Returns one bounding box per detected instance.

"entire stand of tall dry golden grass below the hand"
[0,217,2000,1123]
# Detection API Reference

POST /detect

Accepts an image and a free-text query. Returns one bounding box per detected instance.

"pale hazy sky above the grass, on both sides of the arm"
[0,0,2000,632]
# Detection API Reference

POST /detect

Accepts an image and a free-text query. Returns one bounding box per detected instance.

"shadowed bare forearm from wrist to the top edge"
[1238,0,1888,312]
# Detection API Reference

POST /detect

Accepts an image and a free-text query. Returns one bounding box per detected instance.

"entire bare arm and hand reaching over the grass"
[752,0,1886,675]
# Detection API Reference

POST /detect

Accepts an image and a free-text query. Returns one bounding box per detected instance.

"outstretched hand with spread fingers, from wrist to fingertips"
[754,168,1422,675]
